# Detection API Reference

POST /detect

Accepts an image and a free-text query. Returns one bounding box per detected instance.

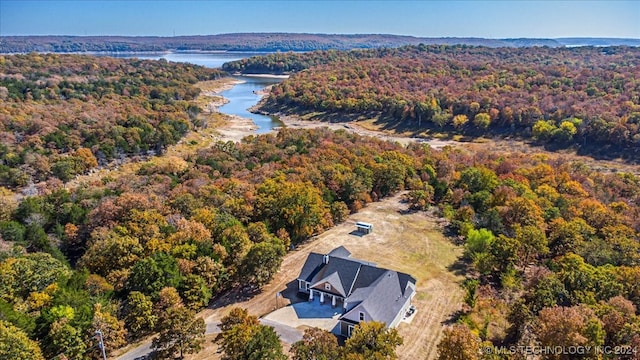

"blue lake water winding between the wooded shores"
[106,51,283,134]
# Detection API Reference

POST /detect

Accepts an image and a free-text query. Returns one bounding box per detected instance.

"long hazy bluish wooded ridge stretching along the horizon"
[0,33,640,53]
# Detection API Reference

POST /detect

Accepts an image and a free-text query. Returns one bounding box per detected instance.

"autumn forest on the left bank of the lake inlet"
[0,54,223,188]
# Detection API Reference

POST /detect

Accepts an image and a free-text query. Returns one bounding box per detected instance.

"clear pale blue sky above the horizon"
[0,0,640,38]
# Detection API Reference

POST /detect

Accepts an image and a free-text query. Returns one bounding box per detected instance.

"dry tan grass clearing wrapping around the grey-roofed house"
[193,195,463,359]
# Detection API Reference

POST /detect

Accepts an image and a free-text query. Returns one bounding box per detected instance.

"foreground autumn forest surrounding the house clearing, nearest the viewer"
[0,123,640,358]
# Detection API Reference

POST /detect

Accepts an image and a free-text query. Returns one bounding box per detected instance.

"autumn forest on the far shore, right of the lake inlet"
[224,45,640,160]
